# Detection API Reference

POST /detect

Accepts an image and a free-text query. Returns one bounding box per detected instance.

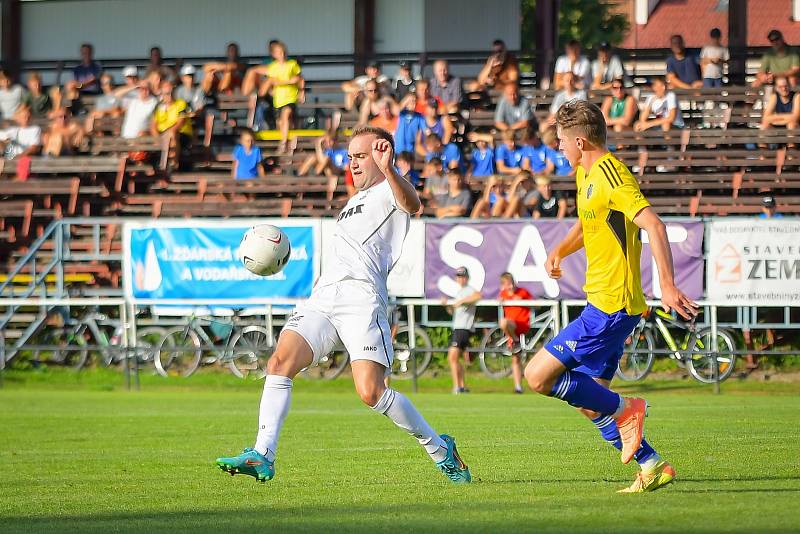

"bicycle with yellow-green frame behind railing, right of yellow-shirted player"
[617,308,736,384]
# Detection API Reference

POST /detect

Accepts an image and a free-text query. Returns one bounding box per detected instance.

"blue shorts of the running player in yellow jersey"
[545,304,640,380]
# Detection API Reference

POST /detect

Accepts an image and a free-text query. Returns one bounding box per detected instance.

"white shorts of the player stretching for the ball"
[283,280,394,373]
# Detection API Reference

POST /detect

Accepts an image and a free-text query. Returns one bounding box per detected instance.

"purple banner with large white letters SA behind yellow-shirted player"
[425,220,703,299]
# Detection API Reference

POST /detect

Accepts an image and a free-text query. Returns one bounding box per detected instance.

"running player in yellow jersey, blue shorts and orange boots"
[525,101,697,493]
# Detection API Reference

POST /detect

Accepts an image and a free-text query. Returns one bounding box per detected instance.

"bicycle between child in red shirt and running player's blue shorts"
[478,310,555,378]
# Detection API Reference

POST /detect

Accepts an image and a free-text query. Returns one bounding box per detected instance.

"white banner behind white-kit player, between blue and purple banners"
[322,219,425,297]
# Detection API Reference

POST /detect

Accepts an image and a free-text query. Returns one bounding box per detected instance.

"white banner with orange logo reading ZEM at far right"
[706,218,800,306]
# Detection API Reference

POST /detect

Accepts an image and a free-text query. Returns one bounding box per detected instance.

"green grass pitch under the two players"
[0,370,800,534]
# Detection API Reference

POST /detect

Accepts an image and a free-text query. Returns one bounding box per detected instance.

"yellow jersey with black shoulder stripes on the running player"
[575,152,650,315]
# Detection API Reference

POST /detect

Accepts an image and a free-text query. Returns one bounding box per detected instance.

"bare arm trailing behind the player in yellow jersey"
[633,207,697,320]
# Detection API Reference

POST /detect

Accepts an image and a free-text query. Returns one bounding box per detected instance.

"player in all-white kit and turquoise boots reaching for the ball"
[217,126,472,483]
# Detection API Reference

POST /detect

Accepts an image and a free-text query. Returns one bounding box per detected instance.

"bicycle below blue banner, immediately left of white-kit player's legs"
[154,315,273,378]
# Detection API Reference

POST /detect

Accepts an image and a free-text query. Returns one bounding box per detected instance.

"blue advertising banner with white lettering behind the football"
[123,219,321,304]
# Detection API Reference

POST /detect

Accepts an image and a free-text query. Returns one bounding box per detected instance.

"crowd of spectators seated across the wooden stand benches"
[0,28,800,218]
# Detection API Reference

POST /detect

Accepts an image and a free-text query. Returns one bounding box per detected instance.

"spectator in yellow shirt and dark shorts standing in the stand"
[242,41,305,154]
